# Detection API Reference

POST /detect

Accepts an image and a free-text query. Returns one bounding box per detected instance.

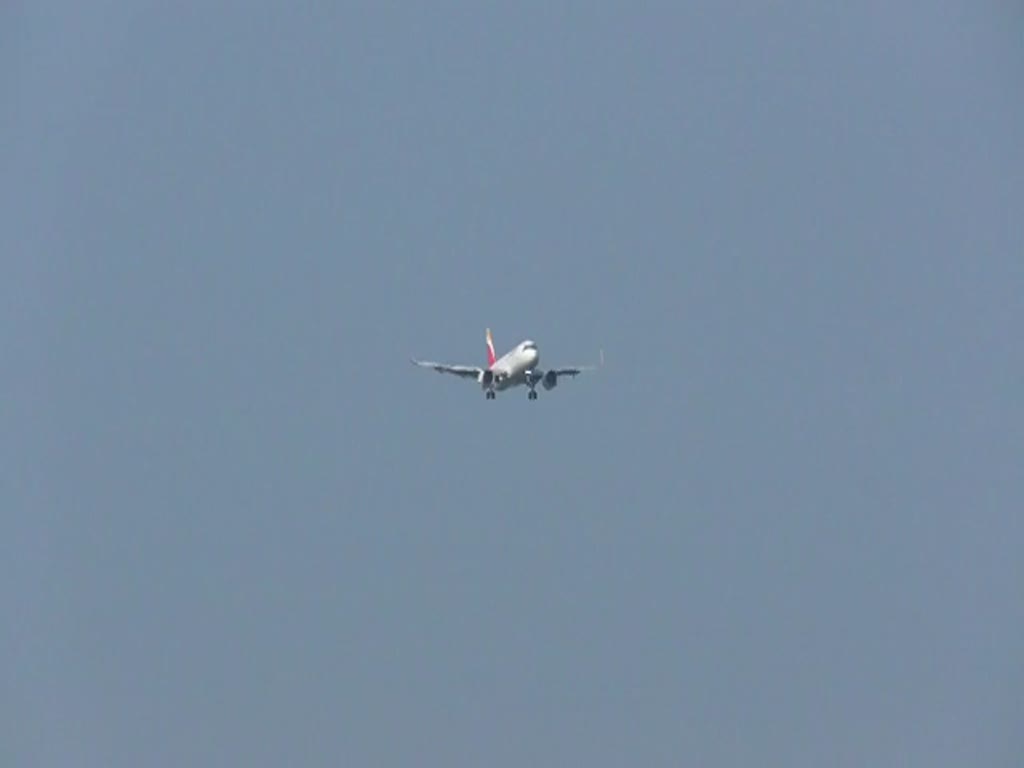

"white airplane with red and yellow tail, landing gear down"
[412,328,604,400]
